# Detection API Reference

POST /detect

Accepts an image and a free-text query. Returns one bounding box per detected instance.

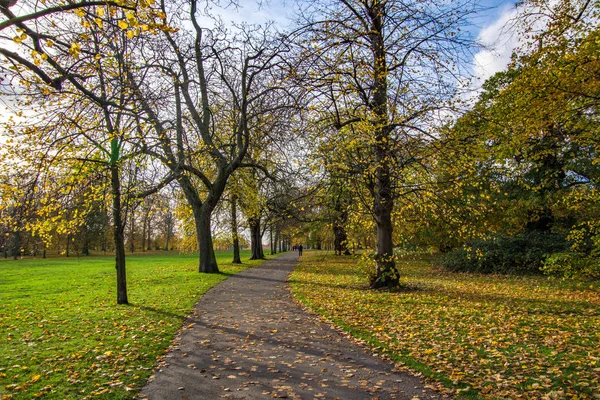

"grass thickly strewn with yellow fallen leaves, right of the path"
[291,252,600,399]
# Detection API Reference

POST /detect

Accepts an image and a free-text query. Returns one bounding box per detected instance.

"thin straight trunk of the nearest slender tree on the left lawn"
[110,164,129,304]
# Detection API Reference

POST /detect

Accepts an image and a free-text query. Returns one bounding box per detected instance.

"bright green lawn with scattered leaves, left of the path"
[0,252,268,400]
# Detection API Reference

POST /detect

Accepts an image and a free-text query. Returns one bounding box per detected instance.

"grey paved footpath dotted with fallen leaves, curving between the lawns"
[140,252,436,400]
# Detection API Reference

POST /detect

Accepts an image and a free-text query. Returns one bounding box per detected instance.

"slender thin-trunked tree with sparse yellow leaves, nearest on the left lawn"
[0,2,170,304]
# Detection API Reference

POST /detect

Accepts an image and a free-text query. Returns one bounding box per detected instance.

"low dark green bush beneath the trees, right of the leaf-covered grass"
[440,232,569,274]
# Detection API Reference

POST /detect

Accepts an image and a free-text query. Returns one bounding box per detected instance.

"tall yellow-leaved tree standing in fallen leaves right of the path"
[290,0,474,288]
